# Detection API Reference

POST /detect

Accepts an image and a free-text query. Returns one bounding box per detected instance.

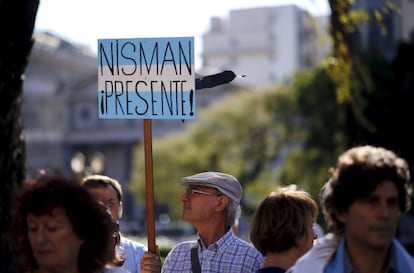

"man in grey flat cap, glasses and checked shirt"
[161,172,263,273]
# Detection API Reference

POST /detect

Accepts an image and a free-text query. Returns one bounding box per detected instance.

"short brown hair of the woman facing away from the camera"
[250,187,318,255]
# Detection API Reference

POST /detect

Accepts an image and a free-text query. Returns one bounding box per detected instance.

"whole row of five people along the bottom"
[7,145,414,273]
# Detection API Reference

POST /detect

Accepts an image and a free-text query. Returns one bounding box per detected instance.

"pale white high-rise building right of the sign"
[203,5,326,88]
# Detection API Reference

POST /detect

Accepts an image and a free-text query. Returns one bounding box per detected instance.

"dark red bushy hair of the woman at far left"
[11,175,122,273]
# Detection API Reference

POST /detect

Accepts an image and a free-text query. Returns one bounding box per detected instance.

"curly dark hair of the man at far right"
[321,145,410,234]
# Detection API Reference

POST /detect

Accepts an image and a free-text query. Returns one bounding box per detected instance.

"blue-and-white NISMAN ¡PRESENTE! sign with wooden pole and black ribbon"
[98,37,238,253]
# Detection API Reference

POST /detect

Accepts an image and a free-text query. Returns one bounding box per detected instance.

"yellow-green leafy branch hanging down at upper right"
[327,0,398,146]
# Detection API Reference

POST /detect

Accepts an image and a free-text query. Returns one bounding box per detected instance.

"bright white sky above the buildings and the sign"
[35,0,329,68]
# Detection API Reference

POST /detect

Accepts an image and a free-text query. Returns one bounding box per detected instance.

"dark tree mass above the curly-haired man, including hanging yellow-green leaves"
[280,0,414,232]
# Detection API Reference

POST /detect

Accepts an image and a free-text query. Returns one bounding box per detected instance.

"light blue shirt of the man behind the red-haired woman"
[119,235,147,273]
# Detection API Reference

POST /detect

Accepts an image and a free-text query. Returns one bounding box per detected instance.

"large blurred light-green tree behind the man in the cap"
[130,67,346,219]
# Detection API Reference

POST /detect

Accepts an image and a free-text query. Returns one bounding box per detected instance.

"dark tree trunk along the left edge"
[0,0,39,273]
